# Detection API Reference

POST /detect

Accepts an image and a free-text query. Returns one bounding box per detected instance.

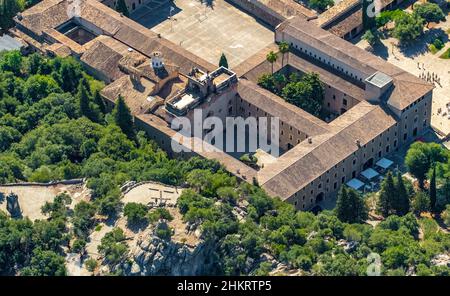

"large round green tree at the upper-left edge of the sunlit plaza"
[392,14,423,44]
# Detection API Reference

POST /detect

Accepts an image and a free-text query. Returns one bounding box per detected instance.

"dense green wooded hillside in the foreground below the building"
[0,52,450,275]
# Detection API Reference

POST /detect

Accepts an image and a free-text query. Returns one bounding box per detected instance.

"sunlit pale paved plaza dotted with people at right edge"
[356,17,450,135]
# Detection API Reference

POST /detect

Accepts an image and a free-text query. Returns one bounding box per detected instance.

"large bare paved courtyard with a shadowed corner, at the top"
[131,0,274,68]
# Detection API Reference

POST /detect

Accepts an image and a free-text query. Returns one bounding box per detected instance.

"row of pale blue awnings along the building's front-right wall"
[347,157,394,193]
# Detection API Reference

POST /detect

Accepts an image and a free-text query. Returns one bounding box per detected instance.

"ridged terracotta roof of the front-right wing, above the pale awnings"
[258,102,396,199]
